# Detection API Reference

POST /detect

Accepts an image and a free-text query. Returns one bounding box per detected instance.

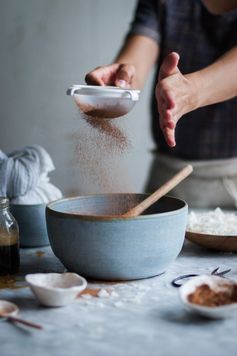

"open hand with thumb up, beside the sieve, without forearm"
[155,52,195,147]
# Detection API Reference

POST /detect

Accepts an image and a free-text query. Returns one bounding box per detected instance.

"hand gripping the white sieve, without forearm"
[85,63,135,88]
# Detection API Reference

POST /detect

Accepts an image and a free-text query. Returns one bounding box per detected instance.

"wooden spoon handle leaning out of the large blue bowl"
[121,164,193,218]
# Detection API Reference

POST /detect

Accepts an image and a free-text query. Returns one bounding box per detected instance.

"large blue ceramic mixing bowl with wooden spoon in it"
[46,194,188,280]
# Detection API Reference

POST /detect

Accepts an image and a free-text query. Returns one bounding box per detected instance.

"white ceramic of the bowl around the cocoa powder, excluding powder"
[179,275,237,319]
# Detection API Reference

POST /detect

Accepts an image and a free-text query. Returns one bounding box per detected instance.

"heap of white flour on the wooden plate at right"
[187,208,237,235]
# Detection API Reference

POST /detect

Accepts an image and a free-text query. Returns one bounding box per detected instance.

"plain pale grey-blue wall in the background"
[0,0,153,195]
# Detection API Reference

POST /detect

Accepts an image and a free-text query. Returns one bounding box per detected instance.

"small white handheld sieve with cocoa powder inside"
[67,85,140,119]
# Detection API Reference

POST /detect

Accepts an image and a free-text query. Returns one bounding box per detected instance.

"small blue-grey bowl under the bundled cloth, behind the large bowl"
[10,203,49,247]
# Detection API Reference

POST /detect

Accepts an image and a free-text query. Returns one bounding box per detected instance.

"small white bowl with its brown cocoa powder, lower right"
[179,275,237,319]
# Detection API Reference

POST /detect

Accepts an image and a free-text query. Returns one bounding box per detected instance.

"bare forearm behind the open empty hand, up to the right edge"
[190,47,237,108]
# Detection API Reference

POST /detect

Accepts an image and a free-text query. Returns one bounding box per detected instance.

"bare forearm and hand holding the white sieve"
[85,35,159,89]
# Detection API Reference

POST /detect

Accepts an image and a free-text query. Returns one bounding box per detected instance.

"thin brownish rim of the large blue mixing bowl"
[46,193,188,222]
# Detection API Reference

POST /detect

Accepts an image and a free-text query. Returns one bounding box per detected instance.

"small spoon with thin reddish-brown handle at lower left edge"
[0,300,43,330]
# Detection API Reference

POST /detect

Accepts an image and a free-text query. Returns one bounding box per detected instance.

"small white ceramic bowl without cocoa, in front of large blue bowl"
[25,272,87,307]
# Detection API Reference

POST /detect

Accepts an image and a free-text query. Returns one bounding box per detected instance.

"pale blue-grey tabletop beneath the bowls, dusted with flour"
[0,243,237,356]
